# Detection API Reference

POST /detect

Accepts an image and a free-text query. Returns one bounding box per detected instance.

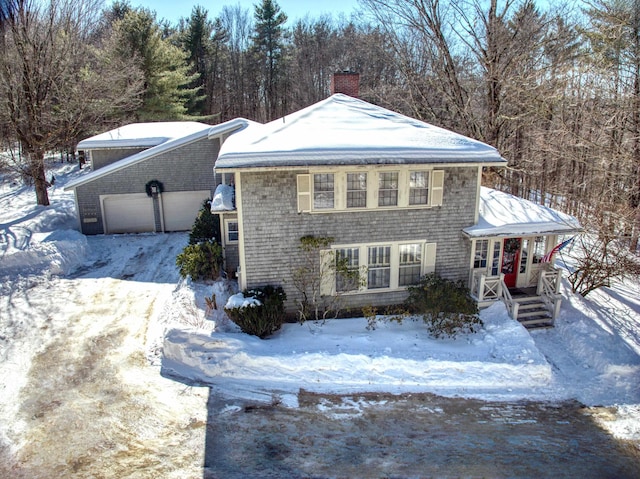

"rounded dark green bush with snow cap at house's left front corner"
[224,286,287,339]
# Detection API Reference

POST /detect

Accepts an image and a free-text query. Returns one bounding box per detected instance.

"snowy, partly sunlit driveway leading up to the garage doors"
[0,235,206,478]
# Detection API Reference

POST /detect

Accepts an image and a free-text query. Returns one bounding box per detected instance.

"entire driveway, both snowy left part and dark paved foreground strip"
[0,231,640,478]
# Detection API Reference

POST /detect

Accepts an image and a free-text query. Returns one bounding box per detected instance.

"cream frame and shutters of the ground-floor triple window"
[321,240,437,295]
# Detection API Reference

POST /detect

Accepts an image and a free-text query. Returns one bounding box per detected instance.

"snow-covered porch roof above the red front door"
[463,187,582,238]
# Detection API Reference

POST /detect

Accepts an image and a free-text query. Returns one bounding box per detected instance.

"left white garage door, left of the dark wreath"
[102,193,156,234]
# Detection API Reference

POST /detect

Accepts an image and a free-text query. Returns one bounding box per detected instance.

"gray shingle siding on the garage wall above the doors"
[75,138,220,235]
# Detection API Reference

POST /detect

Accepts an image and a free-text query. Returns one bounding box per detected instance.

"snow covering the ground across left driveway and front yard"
[0,158,640,477]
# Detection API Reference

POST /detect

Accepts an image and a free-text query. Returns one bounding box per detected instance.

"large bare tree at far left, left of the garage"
[0,0,142,205]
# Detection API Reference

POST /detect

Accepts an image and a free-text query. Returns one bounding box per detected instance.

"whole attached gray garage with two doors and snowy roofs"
[65,119,248,235]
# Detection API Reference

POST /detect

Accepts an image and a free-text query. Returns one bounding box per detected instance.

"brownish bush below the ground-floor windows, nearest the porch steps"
[406,274,482,338]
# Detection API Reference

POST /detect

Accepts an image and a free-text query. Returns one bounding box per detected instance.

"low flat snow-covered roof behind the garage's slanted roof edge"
[77,121,211,150]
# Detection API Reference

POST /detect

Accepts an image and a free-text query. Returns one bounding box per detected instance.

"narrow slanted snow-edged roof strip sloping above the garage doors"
[65,118,253,190]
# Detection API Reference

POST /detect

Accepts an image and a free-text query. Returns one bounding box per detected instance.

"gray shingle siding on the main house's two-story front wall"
[241,167,478,313]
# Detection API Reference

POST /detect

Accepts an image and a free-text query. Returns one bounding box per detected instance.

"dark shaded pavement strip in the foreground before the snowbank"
[204,393,640,479]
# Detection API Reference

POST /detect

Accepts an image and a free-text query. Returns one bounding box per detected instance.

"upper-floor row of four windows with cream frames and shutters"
[296,165,444,213]
